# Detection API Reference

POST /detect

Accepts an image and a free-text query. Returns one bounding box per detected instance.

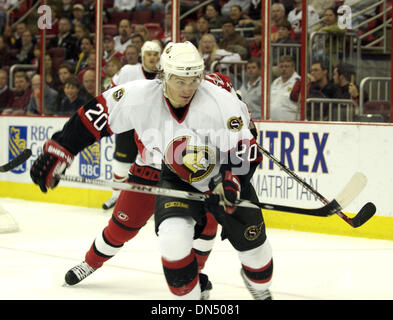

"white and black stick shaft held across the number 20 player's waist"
[57,175,354,217]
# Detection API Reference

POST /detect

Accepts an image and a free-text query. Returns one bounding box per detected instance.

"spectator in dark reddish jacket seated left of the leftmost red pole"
[2,71,32,115]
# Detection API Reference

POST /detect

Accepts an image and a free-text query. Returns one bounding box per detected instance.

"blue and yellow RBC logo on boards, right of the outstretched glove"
[79,141,101,179]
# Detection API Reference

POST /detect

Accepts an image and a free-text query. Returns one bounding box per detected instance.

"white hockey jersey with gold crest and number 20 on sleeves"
[86,79,258,192]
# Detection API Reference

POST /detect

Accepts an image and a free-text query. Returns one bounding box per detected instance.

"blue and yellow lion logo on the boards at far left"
[8,126,27,174]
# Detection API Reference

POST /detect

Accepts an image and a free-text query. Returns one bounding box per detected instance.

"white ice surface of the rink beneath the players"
[0,198,393,300]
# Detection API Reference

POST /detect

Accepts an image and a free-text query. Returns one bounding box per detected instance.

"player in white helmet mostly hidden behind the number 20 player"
[102,41,161,210]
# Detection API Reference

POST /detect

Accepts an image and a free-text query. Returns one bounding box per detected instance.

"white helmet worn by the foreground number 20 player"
[160,41,205,80]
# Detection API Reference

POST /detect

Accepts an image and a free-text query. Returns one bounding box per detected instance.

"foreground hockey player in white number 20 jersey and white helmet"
[31,42,273,299]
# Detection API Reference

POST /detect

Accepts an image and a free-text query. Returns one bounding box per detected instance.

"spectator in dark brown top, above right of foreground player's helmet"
[218,19,249,60]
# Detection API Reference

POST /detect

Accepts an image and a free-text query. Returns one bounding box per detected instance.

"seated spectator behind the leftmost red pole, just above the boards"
[26,74,58,115]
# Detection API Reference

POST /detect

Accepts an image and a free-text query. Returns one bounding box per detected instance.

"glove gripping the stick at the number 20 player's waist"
[209,170,241,214]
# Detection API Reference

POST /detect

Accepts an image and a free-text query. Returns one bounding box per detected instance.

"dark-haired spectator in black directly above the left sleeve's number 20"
[57,76,86,116]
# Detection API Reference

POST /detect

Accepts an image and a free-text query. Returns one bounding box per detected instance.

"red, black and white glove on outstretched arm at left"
[30,140,74,192]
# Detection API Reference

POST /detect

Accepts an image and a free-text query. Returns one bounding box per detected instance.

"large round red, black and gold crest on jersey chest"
[165,137,215,183]
